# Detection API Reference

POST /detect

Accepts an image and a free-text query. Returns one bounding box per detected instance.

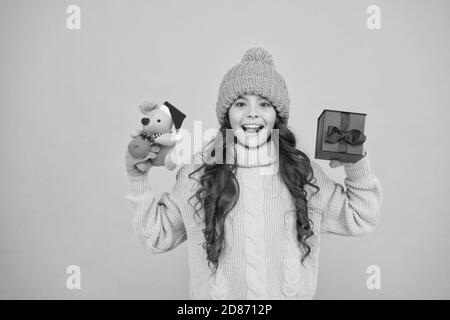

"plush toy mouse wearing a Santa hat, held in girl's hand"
[128,101,186,171]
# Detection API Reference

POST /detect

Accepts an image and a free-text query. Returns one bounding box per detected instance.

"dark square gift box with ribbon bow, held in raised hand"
[315,109,367,163]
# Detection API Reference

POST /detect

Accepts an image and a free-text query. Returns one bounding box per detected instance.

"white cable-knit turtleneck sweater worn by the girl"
[127,139,382,300]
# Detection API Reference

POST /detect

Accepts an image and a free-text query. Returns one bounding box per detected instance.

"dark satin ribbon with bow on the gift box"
[325,112,366,153]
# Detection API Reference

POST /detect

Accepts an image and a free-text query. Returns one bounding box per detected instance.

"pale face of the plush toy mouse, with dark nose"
[139,102,173,133]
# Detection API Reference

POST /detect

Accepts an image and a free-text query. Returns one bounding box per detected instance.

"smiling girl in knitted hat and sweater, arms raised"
[126,47,381,300]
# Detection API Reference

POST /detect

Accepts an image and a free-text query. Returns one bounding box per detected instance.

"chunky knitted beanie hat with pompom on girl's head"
[216,47,290,124]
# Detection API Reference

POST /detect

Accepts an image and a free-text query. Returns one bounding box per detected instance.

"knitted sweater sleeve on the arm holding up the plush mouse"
[126,166,189,253]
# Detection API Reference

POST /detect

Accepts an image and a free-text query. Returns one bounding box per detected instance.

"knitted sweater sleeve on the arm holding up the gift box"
[313,151,382,236]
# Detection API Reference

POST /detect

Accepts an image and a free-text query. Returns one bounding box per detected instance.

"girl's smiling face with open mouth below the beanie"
[228,94,277,147]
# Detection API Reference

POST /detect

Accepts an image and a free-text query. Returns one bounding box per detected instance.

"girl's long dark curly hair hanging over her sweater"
[189,112,320,272]
